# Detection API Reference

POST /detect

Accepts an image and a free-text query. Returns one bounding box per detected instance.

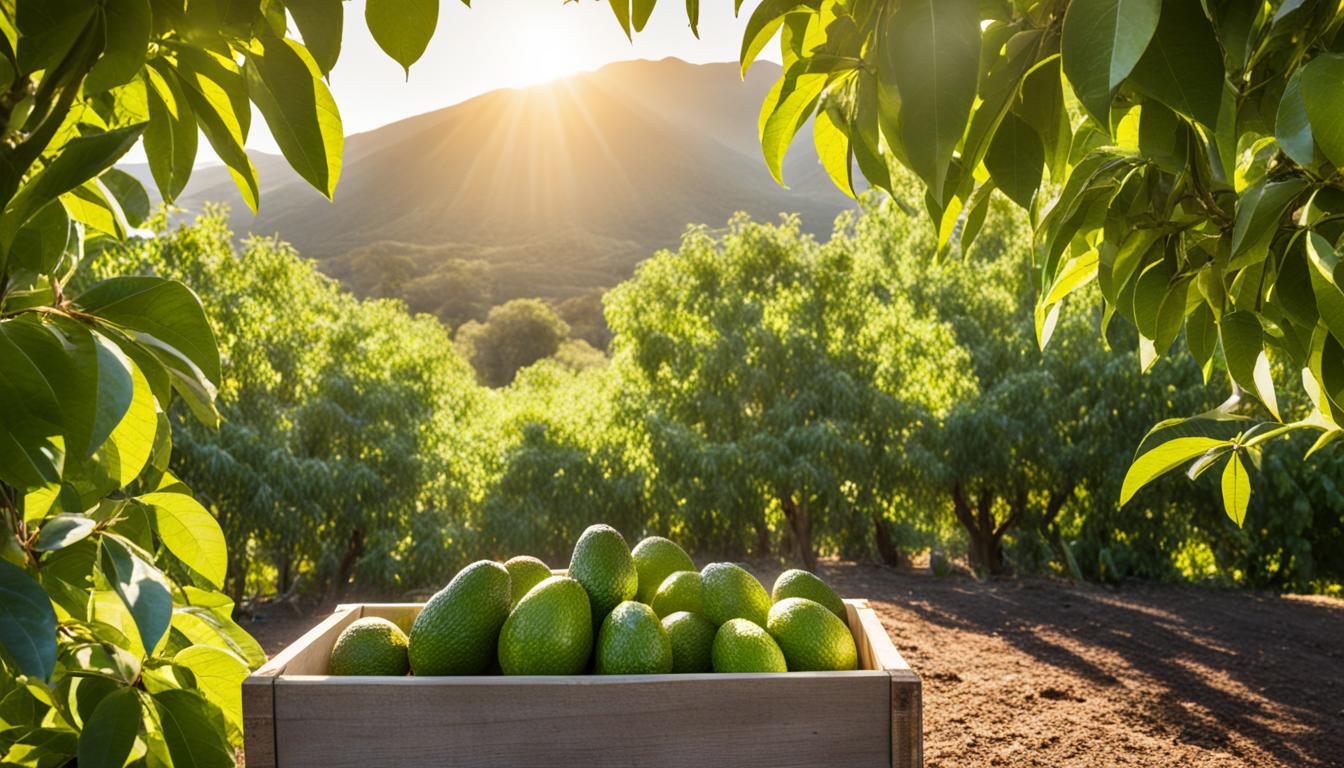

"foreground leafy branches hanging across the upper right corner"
[596,0,1344,525]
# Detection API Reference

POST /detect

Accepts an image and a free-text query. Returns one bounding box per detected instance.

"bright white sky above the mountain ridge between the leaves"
[126,0,778,164]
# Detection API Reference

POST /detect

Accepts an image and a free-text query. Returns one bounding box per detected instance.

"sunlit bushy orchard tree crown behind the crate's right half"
[607,218,965,568]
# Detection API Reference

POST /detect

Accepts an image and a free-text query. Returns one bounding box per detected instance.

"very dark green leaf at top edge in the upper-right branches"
[1129,0,1224,130]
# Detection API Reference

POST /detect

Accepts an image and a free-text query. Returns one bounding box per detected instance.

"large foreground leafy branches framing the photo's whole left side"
[0,0,422,765]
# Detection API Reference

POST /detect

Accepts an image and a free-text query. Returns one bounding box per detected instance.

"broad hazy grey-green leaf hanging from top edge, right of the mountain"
[879,0,980,200]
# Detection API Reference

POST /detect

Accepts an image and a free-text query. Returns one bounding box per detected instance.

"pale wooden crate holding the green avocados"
[243,600,923,768]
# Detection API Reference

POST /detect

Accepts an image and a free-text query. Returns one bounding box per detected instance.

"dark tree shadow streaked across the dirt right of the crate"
[854,574,1344,768]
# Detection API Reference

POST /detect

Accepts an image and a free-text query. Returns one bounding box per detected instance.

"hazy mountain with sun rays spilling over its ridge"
[123,59,852,324]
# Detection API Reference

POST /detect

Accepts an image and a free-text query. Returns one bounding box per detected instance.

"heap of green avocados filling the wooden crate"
[329,525,859,677]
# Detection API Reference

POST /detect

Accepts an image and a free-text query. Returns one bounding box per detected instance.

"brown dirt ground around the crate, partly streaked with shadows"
[245,564,1344,768]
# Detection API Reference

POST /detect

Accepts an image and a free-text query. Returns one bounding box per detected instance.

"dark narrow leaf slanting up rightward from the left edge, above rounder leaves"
[0,122,145,252]
